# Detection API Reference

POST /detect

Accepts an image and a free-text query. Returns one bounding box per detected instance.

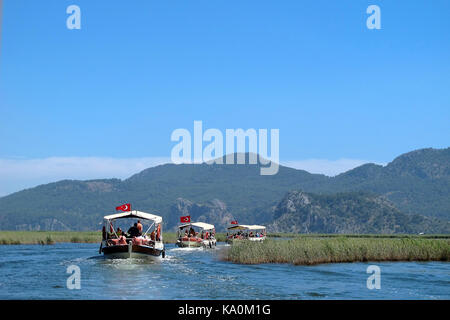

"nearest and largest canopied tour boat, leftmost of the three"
[99,210,165,260]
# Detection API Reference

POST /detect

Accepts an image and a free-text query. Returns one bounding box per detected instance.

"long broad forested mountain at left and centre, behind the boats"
[0,160,330,230]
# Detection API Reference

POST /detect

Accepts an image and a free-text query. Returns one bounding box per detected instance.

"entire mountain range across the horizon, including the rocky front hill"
[0,148,450,233]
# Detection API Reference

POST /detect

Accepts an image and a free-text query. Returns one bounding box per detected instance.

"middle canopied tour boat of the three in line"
[176,222,216,248]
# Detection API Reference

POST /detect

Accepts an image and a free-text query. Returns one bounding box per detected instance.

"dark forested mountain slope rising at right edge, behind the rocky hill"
[322,148,450,219]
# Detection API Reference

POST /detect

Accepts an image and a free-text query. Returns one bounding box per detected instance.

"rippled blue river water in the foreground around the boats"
[0,243,450,300]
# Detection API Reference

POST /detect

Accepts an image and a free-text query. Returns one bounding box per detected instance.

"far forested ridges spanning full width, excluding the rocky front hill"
[0,148,450,230]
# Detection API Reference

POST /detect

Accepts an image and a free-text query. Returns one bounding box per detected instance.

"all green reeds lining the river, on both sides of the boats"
[0,231,450,265]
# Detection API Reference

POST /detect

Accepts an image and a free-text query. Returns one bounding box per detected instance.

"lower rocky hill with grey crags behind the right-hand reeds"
[268,191,450,234]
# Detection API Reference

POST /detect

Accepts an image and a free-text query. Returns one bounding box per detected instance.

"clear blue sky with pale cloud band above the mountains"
[0,0,450,195]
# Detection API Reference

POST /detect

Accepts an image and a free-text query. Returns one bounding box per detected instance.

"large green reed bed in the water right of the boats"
[224,236,450,265]
